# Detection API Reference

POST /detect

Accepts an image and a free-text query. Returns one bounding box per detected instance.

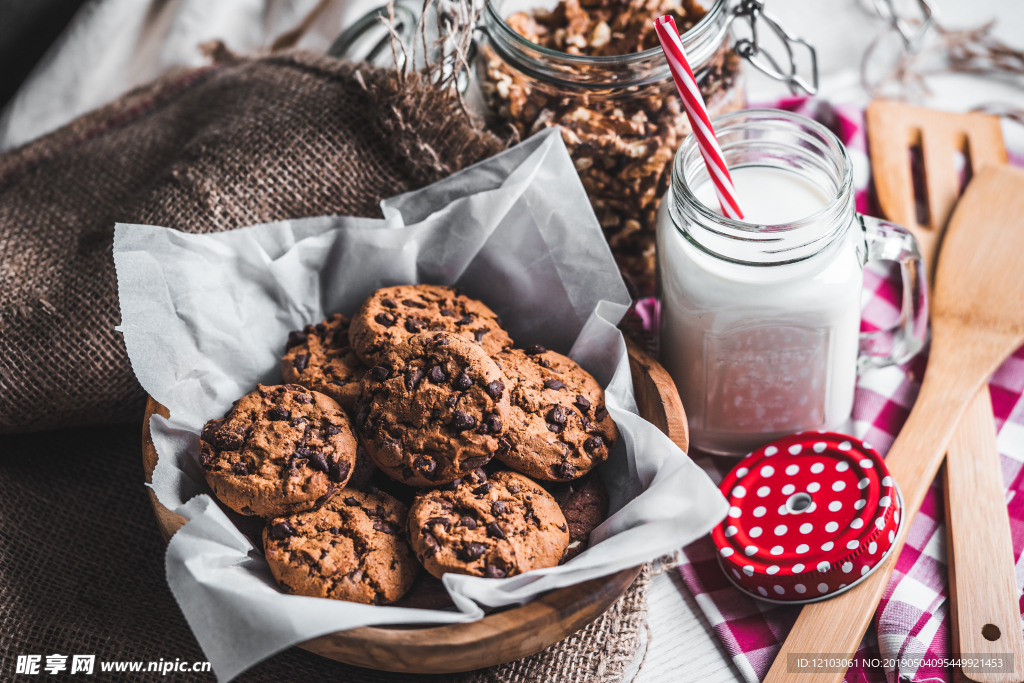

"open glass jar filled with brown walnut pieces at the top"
[476,0,745,296]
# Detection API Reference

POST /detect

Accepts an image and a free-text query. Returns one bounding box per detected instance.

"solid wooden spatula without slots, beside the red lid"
[765,166,1024,683]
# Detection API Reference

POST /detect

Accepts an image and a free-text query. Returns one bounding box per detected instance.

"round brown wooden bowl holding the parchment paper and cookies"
[142,341,689,674]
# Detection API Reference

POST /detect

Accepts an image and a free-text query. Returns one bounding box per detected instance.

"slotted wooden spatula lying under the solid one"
[866,100,1024,683]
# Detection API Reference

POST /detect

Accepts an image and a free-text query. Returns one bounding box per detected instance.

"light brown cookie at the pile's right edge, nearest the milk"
[494,346,618,480]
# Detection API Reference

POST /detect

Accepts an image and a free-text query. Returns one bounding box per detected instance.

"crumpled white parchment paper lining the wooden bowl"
[114,129,728,681]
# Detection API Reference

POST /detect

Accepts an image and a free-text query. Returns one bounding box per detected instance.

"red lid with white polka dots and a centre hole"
[712,432,902,602]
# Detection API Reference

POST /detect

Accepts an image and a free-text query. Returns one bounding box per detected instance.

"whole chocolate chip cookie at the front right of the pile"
[409,469,569,579]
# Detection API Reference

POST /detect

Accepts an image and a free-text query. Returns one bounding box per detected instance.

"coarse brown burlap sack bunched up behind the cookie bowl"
[0,53,503,433]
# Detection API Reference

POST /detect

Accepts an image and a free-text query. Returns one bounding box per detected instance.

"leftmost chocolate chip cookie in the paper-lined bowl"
[200,384,356,517]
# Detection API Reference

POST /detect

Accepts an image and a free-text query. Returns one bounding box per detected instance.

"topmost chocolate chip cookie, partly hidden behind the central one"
[348,285,512,366]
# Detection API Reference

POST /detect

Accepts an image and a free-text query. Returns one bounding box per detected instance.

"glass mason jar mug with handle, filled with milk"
[657,110,928,455]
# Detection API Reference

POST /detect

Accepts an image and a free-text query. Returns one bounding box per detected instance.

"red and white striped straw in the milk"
[654,14,743,220]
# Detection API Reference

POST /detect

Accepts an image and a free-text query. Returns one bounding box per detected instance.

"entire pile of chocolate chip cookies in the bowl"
[201,285,618,606]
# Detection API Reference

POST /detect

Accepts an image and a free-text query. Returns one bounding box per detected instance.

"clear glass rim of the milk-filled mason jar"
[672,109,853,234]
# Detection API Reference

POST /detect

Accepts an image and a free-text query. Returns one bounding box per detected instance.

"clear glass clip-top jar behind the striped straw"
[476,0,745,295]
